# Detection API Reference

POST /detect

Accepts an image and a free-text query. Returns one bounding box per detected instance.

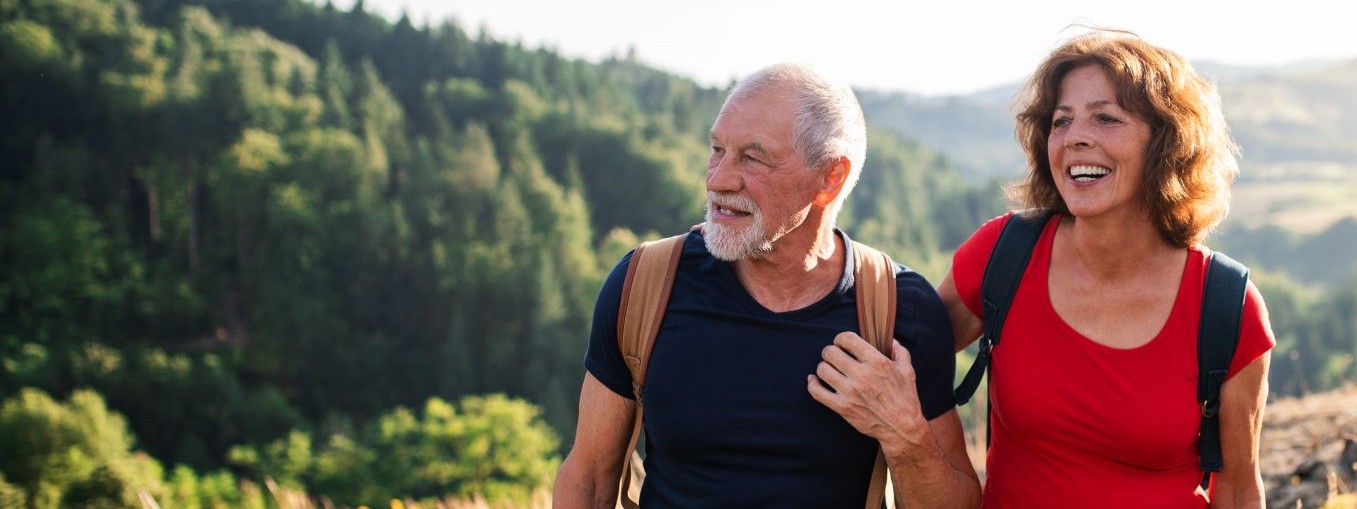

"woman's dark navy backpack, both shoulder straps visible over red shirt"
[957,210,1248,487]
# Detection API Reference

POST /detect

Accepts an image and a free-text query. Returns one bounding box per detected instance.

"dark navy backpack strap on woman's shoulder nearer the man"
[955,210,1052,406]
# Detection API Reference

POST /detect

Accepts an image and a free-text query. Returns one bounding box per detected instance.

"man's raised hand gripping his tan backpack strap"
[806,333,932,453]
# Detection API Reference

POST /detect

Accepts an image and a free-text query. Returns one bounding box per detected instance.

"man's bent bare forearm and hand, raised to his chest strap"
[806,333,980,508]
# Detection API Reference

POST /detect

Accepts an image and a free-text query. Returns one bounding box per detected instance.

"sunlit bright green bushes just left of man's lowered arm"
[231,395,560,505]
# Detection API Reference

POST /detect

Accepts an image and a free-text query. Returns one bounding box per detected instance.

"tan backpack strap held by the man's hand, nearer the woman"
[852,242,896,509]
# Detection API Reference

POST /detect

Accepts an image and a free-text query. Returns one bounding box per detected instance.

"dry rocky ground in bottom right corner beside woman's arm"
[1259,385,1357,509]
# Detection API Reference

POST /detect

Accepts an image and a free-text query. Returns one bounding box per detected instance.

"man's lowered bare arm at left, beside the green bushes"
[551,372,636,509]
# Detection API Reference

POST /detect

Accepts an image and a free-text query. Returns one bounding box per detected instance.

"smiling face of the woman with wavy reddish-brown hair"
[1046,65,1149,217]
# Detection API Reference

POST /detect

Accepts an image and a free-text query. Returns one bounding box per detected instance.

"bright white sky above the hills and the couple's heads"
[347,0,1357,95]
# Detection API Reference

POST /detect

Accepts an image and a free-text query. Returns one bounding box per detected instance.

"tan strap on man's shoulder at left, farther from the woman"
[617,233,688,509]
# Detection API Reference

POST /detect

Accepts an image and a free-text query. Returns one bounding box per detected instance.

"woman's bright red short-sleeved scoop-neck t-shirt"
[951,213,1276,509]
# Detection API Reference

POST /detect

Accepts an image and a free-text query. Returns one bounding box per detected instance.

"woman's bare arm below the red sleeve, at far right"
[1210,352,1272,509]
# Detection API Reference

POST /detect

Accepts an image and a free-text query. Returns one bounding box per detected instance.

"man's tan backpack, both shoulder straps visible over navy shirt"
[617,227,896,509]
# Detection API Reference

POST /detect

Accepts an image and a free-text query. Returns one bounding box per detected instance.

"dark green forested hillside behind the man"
[0,0,1000,506]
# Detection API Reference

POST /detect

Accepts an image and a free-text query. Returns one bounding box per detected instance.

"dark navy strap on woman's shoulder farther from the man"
[1197,252,1248,487]
